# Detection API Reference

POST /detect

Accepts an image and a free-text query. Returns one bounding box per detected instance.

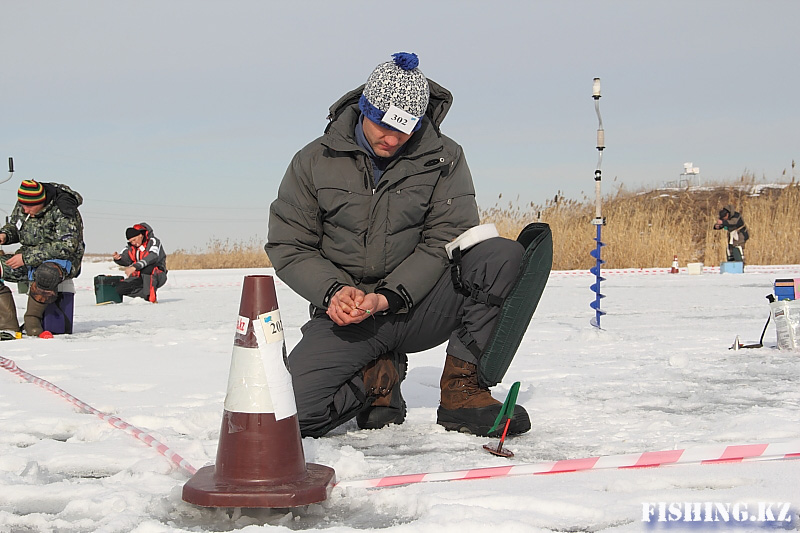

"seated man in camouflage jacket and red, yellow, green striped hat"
[0,180,86,337]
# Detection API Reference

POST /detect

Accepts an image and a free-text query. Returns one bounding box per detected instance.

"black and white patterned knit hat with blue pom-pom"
[358,52,430,131]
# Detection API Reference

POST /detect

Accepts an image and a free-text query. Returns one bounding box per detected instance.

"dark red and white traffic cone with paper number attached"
[183,276,335,507]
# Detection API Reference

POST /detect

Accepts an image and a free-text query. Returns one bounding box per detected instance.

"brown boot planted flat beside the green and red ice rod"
[436,355,531,437]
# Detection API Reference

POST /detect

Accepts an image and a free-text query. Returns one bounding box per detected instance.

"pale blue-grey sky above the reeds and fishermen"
[0,0,800,252]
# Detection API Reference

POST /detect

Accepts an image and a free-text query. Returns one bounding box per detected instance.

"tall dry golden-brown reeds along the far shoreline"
[136,175,800,270]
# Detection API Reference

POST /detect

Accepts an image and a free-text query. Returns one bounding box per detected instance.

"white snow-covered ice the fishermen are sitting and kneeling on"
[0,262,800,533]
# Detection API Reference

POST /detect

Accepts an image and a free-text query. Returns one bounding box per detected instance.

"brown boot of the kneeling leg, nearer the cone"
[356,352,408,429]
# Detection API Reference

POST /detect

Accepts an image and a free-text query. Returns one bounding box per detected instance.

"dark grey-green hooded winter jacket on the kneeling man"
[265,80,479,312]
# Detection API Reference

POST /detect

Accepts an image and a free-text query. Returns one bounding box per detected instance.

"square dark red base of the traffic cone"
[182,463,336,508]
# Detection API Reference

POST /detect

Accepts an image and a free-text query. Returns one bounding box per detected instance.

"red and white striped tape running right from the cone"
[336,441,800,489]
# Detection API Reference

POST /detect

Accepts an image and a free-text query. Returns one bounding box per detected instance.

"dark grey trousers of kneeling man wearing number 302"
[289,237,524,437]
